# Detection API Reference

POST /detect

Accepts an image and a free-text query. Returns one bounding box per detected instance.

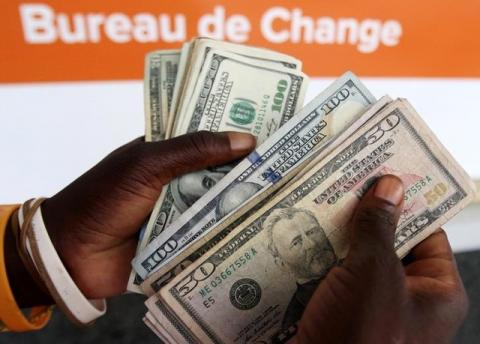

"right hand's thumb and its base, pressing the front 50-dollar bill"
[298,175,408,343]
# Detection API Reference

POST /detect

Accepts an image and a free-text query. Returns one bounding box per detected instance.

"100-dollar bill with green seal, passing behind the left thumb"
[133,49,308,290]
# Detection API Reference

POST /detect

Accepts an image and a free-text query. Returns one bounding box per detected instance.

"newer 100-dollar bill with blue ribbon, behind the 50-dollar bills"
[132,72,375,279]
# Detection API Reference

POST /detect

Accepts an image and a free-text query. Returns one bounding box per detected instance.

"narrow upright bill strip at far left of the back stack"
[143,50,180,141]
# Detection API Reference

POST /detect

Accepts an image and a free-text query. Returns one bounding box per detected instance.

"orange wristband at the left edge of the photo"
[0,205,52,332]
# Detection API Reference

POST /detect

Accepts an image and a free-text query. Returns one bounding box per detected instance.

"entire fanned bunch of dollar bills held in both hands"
[128,38,475,343]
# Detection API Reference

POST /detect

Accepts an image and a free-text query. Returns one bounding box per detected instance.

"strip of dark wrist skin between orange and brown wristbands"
[5,214,54,308]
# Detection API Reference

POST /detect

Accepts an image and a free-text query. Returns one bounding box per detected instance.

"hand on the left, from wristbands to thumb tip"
[42,132,255,298]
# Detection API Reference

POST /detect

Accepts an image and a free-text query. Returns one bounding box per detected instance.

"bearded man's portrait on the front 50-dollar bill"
[263,208,337,330]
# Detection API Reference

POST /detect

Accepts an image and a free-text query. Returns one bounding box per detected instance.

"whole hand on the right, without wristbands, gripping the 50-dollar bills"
[296,176,468,344]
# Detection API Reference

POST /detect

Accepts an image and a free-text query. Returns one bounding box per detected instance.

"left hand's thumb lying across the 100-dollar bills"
[138,131,256,184]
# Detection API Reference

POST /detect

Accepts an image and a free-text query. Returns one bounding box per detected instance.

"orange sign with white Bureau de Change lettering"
[0,0,480,83]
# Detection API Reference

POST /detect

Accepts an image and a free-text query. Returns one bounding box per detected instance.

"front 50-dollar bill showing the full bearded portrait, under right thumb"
[160,100,474,343]
